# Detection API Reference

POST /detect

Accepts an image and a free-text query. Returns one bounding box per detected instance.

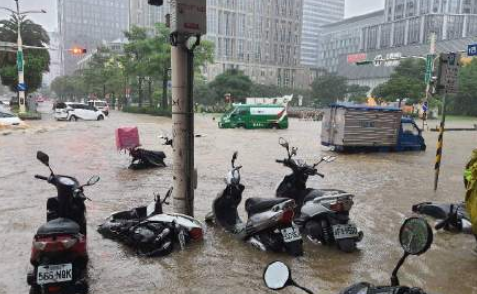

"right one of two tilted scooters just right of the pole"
[276,138,363,252]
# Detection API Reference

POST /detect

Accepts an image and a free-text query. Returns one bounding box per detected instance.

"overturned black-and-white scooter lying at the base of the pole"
[98,188,204,257]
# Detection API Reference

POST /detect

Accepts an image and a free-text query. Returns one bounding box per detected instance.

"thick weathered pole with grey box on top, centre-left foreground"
[170,0,207,216]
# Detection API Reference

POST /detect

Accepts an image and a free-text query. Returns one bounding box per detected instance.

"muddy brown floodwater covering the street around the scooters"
[0,104,477,294]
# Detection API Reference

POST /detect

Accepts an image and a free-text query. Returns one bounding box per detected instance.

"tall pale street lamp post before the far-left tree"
[0,0,46,113]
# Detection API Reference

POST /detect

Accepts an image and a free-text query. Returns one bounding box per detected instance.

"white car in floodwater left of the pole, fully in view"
[54,102,105,121]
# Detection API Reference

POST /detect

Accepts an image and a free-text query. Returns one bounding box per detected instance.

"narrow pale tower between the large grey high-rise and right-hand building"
[301,0,345,68]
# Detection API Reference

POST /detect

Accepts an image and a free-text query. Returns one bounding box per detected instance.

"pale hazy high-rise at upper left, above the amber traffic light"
[58,0,129,74]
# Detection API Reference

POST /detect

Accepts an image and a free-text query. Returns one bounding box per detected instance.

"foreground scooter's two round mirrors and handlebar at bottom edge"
[263,217,433,294]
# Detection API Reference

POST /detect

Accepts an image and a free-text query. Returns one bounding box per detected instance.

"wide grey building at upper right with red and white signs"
[321,0,477,89]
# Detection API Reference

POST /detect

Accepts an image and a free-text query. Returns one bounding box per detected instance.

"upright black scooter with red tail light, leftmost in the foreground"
[27,151,99,294]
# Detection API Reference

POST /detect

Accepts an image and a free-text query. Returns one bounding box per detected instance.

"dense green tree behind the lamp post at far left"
[0,15,50,93]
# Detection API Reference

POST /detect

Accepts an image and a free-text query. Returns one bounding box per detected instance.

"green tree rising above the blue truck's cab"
[372,59,426,104]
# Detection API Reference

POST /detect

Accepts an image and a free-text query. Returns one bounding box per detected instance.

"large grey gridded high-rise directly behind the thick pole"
[129,0,306,87]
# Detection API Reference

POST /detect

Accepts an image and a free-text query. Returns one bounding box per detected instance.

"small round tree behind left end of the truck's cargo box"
[311,73,348,106]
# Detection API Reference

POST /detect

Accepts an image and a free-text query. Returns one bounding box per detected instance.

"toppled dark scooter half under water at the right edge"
[412,202,473,234]
